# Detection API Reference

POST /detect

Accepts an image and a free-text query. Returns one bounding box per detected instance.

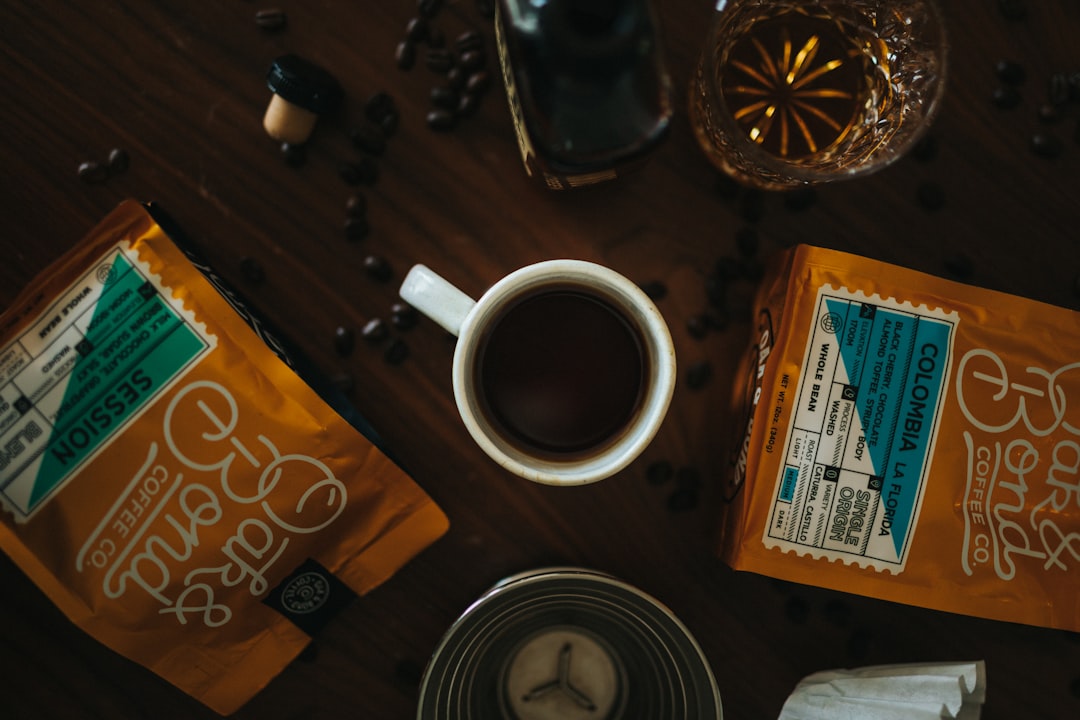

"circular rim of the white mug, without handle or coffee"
[453,259,675,486]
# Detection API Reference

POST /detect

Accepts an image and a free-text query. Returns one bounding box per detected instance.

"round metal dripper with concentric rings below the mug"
[417,568,723,720]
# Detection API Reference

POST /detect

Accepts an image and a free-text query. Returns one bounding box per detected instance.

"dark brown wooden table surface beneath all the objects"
[0,0,1080,720]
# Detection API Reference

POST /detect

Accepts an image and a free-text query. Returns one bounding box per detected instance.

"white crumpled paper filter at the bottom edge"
[778,661,986,720]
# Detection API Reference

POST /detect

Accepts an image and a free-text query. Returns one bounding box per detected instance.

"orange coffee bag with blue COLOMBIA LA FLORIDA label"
[720,246,1080,630]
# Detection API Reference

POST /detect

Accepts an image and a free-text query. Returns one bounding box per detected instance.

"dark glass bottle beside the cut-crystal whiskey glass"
[496,0,672,190]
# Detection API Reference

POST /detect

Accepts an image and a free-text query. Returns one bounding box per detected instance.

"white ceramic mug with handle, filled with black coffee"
[401,260,675,485]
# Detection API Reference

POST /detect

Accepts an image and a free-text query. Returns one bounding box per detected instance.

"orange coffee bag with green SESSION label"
[0,201,447,714]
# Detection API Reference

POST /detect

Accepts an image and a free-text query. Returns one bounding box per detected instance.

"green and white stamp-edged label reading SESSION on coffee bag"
[0,246,214,521]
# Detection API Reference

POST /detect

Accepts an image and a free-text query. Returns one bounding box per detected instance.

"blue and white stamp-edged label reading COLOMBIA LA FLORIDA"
[764,286,958,572]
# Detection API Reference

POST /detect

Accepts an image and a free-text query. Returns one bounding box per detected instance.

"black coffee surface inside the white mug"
[474,284,649,460]
